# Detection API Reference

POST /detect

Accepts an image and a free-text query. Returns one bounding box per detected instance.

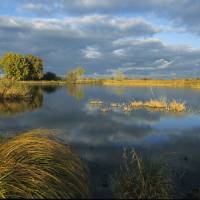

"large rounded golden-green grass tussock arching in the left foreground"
[0,130,89,199]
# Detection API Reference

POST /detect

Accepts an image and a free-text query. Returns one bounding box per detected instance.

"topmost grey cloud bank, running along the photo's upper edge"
[14,0,200,34]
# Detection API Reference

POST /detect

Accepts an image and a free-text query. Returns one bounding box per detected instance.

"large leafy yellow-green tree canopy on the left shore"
[0,52,43,80]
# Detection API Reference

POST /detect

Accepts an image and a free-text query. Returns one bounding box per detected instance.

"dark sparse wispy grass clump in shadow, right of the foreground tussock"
[112,150,172,199]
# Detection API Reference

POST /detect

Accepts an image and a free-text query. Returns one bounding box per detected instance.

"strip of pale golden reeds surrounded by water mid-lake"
[89,98,188,113]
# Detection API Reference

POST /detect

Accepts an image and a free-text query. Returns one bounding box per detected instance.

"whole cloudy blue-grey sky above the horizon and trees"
[0,0,200,78]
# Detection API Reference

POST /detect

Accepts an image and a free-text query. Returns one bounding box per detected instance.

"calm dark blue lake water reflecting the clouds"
[0,86,200,197]
